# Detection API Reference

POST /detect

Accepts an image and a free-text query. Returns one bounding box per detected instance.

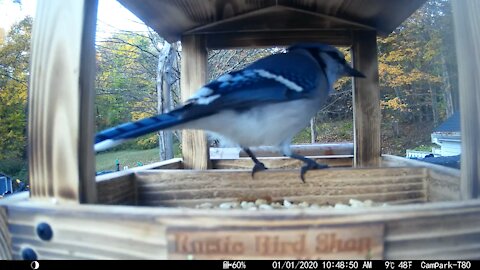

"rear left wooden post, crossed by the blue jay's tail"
[180,35,209,170]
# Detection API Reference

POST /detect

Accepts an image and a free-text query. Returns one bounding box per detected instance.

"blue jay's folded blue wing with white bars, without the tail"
[182,53,322,117]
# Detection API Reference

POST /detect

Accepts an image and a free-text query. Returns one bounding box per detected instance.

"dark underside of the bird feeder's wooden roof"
[118,0,426,42]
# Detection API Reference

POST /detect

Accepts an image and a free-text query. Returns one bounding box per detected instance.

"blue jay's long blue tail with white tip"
[95,107,193,152]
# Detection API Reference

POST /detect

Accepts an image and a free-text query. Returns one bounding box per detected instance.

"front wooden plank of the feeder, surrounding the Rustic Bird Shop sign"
[3,200,480,259]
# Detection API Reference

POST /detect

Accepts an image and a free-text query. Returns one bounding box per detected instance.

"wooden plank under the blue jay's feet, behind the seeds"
[136,168,427,207]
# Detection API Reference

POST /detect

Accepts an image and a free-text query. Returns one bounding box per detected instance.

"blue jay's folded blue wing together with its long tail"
[95,52,325,151]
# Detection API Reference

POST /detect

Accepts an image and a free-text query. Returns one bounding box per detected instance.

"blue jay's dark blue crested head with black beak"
[288,43,365,78]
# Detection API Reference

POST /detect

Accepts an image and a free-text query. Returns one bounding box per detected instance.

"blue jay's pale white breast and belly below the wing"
[185,99,321,147]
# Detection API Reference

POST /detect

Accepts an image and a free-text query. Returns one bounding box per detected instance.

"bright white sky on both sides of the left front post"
[0,0,147,39]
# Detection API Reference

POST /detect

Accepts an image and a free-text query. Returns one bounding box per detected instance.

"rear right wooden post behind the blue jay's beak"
[352,31,382,167]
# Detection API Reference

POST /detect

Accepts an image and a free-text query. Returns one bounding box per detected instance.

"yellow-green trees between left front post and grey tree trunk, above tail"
[95,32,158,133]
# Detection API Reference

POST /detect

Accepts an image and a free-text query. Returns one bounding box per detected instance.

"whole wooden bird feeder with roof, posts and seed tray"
[0,0,480,259]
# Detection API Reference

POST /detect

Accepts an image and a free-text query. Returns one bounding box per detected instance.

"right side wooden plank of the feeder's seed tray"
[382,155,460,202]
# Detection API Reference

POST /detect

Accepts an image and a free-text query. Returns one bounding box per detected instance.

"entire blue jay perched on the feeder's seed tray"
[95,44,364,182]
